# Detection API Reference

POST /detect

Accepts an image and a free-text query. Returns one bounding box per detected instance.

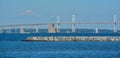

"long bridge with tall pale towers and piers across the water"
[0,15,120,33]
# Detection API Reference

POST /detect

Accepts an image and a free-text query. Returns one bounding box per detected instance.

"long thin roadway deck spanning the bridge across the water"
[0,22,120,28]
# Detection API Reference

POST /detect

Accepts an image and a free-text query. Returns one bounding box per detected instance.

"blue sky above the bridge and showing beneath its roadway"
[0,0,120,29]
